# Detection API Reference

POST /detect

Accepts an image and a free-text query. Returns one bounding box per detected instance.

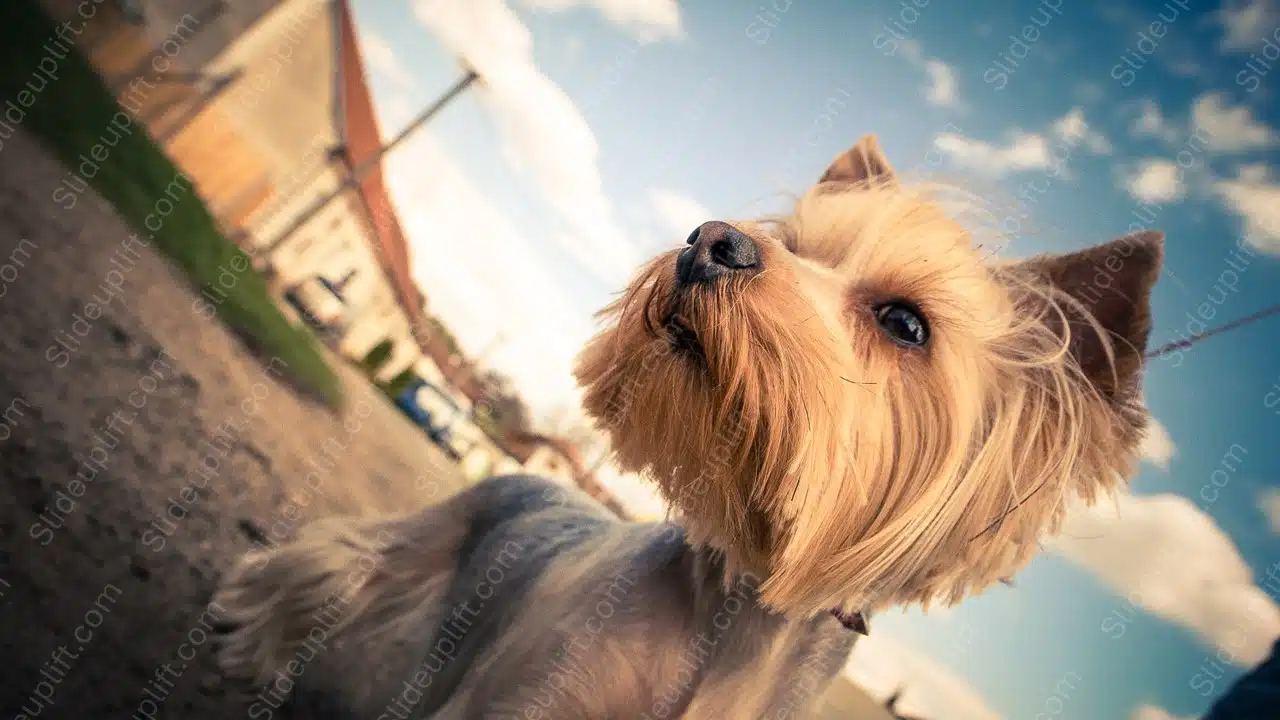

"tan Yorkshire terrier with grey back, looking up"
[214,137,1162,720]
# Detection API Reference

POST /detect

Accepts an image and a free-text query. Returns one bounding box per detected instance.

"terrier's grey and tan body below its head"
[218,477,851,720]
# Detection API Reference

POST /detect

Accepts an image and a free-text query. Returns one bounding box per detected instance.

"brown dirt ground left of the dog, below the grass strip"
[0,135,462,719]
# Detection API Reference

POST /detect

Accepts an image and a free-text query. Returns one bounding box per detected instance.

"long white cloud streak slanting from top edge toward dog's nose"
[415,0,678,287]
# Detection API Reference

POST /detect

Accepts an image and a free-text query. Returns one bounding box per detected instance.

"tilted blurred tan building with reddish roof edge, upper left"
[44,0,442,380]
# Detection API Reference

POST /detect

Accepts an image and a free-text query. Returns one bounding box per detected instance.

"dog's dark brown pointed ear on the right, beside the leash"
[1018,231,1165,405]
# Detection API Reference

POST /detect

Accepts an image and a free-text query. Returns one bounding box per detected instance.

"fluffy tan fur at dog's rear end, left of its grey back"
[211,492,472,685]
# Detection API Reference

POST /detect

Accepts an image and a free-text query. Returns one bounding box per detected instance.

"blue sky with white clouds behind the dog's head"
[355,0,1280,720]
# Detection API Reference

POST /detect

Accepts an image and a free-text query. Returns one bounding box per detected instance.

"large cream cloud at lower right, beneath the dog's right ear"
[1046,493,1280,665]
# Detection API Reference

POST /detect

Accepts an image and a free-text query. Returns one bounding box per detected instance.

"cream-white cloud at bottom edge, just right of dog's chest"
[845,633,1000,720]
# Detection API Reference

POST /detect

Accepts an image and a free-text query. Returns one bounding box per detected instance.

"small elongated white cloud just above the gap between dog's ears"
[933,108,1111,176]
